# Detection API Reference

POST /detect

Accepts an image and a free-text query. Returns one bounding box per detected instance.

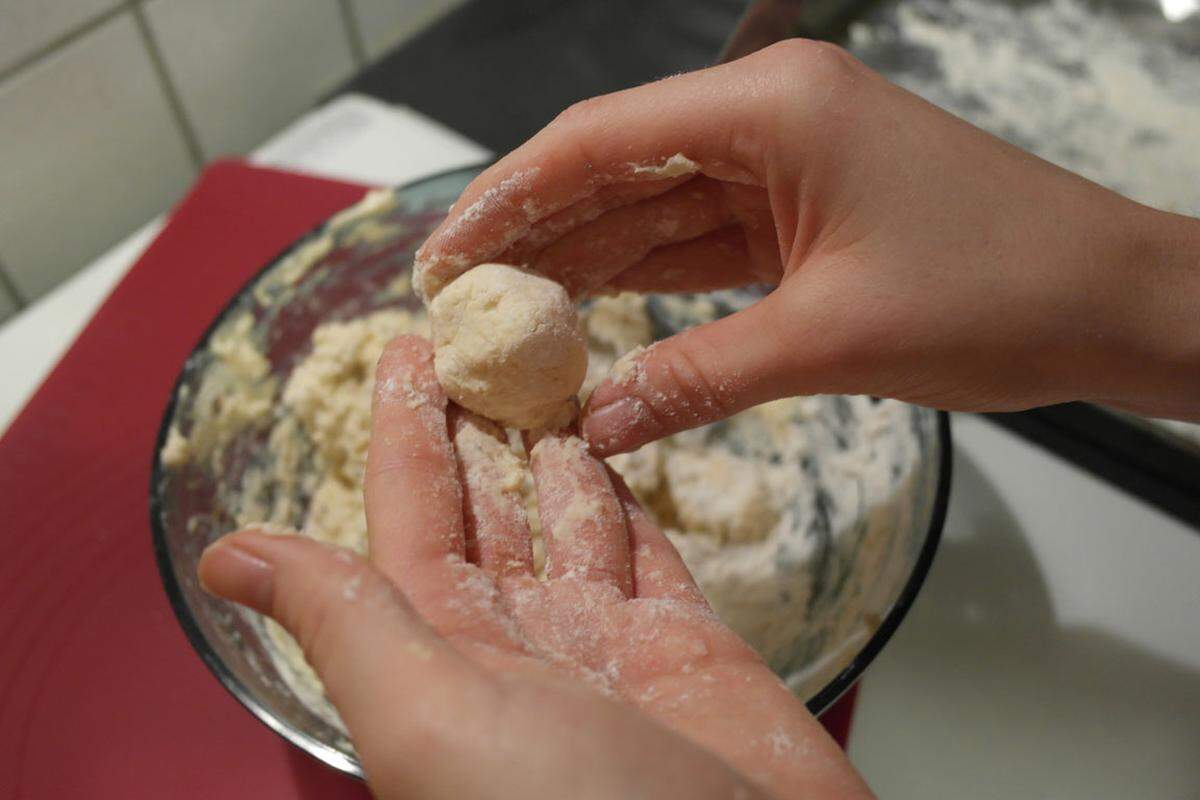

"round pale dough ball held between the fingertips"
[430,264,588,429]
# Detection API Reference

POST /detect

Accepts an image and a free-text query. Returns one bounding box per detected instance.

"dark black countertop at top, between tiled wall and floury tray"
[340,0,746,154]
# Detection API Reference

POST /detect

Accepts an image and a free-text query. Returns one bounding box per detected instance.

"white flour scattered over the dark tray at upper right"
[848,0,1200,446]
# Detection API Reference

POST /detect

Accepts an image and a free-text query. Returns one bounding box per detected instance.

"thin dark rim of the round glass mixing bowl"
[149,162,953,780]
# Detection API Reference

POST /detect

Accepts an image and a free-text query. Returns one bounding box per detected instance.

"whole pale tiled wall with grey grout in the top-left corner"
[0,0,451,321]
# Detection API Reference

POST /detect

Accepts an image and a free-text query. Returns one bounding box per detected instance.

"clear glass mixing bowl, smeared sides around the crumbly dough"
[150,168,950,777]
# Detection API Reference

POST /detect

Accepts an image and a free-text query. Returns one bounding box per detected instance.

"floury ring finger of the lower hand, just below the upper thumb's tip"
[529,432,632,596]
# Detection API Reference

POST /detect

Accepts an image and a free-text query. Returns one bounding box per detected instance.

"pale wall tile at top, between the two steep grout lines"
[145,0,355,158]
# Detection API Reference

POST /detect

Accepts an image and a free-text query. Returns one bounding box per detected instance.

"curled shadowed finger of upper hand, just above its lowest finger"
[532,178,733,297]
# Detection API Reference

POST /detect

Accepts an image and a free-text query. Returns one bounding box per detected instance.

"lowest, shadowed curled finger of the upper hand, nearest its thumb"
[607,227,755,291]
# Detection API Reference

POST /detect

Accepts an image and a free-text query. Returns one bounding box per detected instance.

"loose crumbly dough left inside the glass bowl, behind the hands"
[163,287,924,718]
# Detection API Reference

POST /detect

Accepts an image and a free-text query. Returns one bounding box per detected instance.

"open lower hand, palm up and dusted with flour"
[199,337,870,799]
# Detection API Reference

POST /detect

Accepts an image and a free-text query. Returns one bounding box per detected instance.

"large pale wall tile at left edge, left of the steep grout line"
[0,13,194,300]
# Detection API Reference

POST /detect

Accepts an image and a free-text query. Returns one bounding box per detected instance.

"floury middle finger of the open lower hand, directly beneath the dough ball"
[450,405,533,576]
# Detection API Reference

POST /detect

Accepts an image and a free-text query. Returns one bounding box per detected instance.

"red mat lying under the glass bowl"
[0,162,853,800]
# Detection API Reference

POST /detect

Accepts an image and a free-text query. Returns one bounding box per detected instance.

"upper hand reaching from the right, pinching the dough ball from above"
[418,40,1200,455]
